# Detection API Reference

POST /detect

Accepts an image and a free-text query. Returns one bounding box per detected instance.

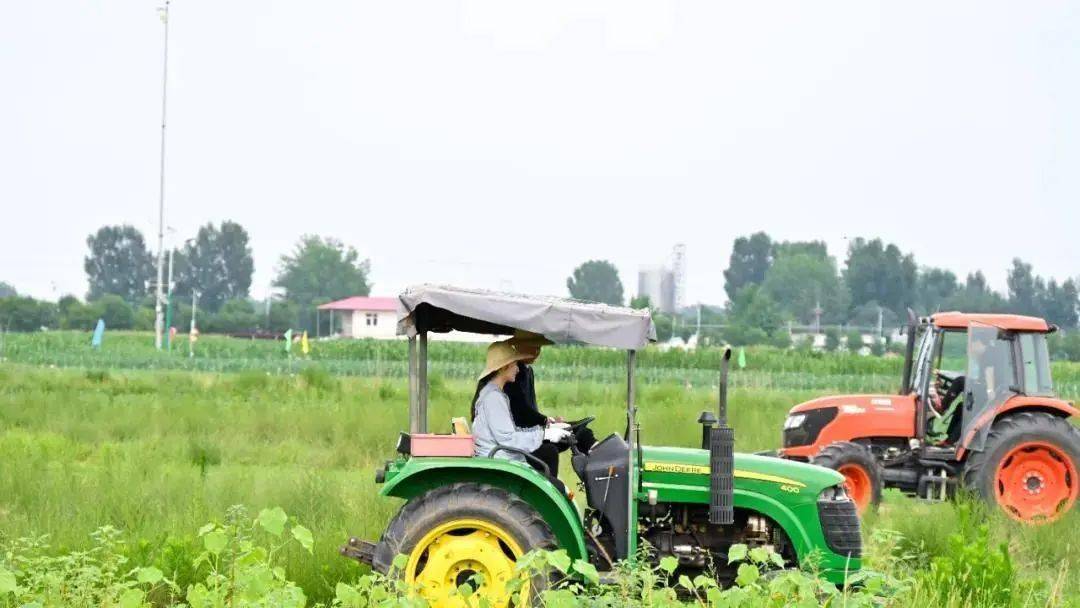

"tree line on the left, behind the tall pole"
[0,221,370,333]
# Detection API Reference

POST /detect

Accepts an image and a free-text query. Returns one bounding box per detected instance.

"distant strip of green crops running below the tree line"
[0,332,1080,400]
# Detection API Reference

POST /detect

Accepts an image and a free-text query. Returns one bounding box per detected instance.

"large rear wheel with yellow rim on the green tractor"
[372,483,556,608]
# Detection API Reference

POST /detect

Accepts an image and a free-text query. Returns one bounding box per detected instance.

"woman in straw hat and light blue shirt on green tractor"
[472,342,570,477]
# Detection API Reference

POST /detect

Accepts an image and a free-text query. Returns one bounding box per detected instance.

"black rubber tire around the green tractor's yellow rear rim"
[372,483,557,604]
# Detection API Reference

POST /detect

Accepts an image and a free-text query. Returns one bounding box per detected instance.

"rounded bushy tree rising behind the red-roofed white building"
[274,234,372,309]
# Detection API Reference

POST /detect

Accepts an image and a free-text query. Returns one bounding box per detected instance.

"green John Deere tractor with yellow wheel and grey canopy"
[341,285,862,607]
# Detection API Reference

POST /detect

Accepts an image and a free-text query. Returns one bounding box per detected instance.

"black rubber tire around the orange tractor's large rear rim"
[961,411,1080,523]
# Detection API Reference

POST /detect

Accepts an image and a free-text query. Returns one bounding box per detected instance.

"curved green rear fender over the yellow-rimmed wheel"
[379,458,589,559]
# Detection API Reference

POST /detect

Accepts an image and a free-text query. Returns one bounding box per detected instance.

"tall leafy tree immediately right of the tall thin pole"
[174,221,255,312]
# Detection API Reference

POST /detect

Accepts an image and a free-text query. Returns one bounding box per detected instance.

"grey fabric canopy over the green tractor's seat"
[397,284,657,350]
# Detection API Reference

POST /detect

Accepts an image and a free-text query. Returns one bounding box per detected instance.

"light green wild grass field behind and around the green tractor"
[0,362,1080,606]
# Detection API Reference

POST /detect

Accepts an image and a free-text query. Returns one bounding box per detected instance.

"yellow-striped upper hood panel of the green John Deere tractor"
[642,446,843,496]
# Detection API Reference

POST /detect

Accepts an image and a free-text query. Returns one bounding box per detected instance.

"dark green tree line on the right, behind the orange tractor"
[567,232,1080,360]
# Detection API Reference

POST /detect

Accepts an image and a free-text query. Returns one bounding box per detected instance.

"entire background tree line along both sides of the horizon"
[0,226,1080,360]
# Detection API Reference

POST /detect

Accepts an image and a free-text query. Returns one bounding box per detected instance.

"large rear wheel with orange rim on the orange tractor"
[963,411,1080,524]
